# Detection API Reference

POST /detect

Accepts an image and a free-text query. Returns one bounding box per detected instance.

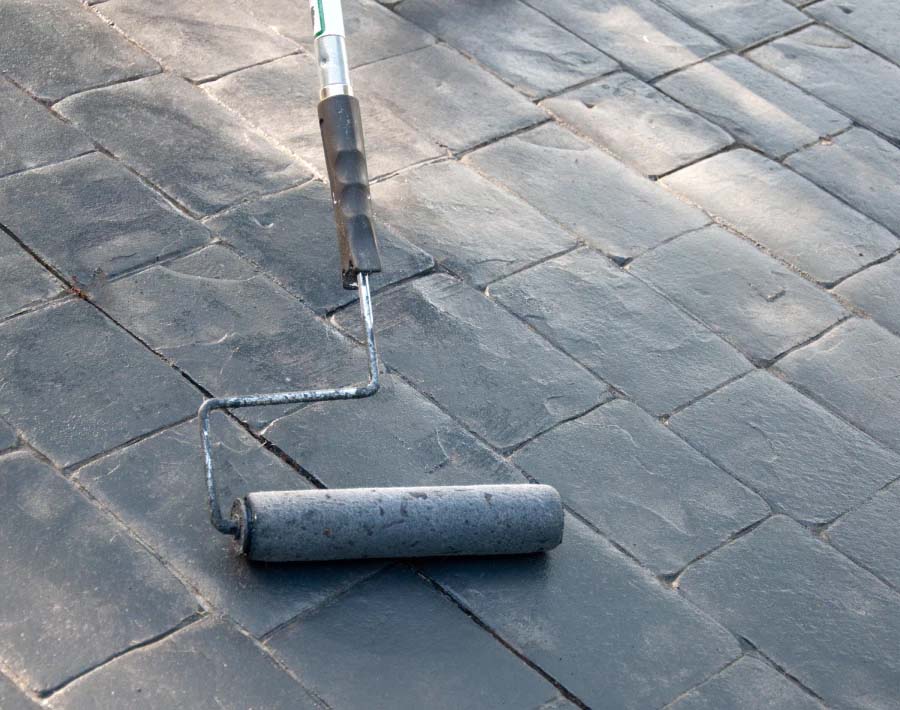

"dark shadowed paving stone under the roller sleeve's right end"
[426,517,740,709]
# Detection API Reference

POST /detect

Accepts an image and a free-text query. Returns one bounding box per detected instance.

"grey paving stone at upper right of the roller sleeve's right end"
[513,400,769,574]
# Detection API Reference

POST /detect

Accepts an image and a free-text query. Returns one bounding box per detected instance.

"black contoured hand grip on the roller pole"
[319,94,381,289]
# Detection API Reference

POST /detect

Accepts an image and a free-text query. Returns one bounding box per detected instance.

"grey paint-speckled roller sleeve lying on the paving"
[232,484,563,562]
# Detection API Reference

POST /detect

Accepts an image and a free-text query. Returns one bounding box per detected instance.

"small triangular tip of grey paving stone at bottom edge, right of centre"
[666,656,824,710]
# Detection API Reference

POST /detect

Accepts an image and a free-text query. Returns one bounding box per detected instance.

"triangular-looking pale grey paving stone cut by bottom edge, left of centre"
[50,619,320,710]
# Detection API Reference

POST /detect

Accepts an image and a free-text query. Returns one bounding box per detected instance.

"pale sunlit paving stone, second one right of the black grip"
[465,124,708,262]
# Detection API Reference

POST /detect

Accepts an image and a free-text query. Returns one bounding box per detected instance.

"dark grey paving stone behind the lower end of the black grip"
[207,182,434,313]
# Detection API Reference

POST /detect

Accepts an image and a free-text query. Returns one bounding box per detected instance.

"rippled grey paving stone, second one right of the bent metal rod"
[490,249,750,416]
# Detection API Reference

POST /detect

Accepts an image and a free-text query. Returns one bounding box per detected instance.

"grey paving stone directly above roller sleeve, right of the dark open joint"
[266,375,525,488]
